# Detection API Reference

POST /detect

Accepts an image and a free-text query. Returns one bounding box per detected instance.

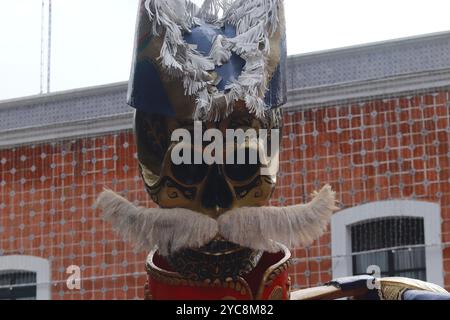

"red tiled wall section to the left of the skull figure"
[0,132,150,299]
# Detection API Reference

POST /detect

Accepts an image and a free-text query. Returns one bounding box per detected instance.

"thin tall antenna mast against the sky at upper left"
[40,0,52,94]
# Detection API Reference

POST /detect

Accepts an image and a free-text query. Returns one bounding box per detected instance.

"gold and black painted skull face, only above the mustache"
[135,104,281,218]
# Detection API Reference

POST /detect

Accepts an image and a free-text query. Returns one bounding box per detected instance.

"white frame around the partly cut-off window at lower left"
[0,255,51,300]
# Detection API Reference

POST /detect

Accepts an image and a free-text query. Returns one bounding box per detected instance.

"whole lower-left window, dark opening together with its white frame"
[0,255,51,300]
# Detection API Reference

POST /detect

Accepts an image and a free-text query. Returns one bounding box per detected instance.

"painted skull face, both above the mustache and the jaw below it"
[135,105,282,280]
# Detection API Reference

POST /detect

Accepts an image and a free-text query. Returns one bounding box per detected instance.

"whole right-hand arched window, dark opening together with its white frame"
[331,200,444,285]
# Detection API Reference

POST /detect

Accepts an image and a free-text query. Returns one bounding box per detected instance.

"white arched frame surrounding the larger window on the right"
[331,200,444,286]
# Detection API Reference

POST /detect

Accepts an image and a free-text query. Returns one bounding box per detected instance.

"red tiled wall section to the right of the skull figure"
[273,92,450,288]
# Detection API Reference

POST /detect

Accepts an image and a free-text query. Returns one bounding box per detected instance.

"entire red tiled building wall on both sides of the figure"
[0,92,450,299]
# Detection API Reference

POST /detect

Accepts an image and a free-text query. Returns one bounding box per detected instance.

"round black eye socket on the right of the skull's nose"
[225,148,261,182]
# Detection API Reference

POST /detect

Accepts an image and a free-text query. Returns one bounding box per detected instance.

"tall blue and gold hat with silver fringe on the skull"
[128,0,287,121]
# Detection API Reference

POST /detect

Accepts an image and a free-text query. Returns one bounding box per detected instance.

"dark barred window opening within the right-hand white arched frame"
[351,217,426,281]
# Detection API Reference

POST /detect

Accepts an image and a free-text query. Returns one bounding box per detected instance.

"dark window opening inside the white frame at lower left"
[0,270,37,300]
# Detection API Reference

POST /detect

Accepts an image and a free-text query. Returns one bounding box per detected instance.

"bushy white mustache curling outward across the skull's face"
[96,185,338,256]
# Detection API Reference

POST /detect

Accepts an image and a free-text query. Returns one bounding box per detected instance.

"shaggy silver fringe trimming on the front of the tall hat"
[145,0,283,121]
